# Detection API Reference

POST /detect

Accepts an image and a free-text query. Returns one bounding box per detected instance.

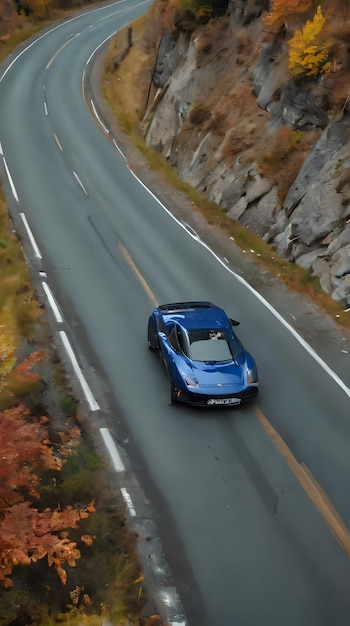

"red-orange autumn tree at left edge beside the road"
[0,404,94,587]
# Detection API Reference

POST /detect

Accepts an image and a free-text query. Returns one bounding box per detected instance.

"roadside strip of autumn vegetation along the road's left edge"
[0,185,156,626]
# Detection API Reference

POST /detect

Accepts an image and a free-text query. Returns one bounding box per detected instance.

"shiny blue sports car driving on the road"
[148,302,258,407]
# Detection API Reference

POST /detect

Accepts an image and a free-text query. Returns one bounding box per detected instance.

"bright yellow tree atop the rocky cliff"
[289,6,332,76]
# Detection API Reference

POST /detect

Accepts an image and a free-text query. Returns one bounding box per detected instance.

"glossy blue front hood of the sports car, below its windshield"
[192,361,244,388]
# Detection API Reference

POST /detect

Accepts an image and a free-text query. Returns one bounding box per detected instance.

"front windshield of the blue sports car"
[188,328,234,362]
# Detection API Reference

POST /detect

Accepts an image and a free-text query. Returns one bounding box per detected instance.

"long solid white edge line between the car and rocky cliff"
[129,170,350,398]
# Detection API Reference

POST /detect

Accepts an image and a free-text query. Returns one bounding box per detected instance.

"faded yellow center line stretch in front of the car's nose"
[255,406,350,556]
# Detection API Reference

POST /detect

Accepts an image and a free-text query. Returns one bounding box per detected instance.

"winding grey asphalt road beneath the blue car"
[0,1,350,626]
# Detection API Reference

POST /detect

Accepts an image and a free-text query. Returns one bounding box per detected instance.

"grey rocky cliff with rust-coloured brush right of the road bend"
[136,0,350,307]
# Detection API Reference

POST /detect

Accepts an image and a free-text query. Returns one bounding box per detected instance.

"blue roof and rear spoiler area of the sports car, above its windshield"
[158,301,229,330]
